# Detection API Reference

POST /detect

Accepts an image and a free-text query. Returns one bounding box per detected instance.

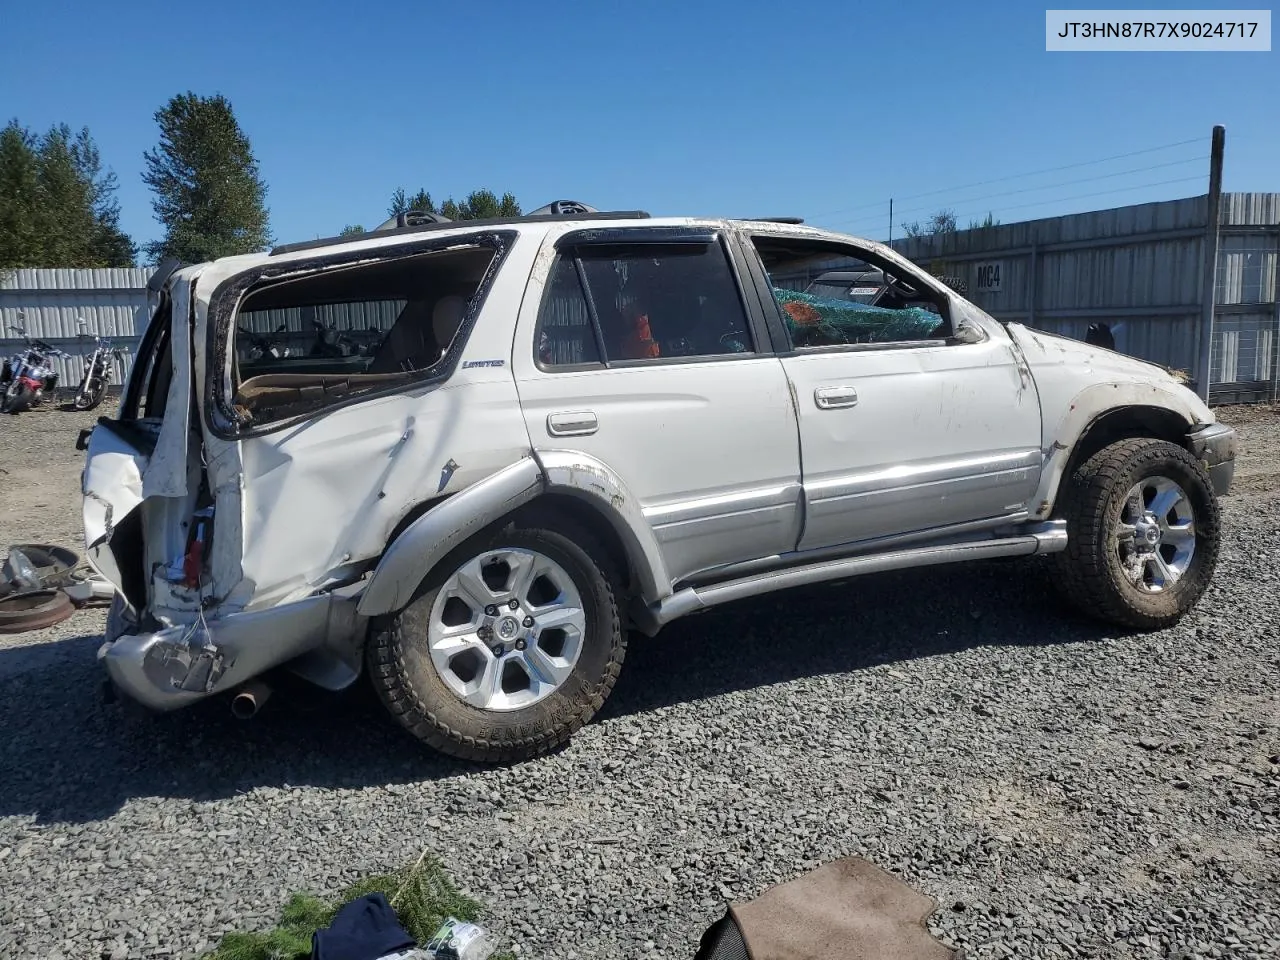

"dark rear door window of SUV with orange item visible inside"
[536,243,755,366]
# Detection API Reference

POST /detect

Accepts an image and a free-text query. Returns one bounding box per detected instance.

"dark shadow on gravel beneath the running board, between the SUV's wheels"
[602,559,1117,717]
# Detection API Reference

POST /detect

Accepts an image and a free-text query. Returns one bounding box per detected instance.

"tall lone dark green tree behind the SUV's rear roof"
[142,92,271,262]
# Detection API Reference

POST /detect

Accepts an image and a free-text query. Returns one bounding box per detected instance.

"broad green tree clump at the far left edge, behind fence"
[0,120,137,268]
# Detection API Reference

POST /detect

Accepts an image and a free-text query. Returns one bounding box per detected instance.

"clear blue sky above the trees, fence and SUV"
[0,0,1280,253]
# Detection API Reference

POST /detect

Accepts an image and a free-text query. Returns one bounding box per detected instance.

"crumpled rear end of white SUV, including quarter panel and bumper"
[81,224,527,716]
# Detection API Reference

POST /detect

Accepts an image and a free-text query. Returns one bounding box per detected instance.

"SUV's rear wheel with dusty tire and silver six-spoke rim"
[366,524,626,763]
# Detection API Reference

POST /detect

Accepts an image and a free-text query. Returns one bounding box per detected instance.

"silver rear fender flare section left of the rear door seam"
[358,457,543,617]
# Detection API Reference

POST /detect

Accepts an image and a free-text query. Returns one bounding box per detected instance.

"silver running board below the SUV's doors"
[637,520,1066,634]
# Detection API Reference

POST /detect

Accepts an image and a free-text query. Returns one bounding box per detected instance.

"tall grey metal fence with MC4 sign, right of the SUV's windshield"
[893,193,1280,403]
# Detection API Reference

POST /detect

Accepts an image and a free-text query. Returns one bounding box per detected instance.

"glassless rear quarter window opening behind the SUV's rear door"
[232,247,495,424]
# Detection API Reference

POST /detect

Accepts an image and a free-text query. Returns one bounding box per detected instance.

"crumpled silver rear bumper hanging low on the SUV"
[97,591,367,710]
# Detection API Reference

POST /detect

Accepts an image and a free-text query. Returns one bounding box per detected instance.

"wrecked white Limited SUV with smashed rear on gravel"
[82,204,1235,760]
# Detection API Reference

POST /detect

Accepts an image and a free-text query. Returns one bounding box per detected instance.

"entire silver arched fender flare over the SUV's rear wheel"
[357,451,671,617]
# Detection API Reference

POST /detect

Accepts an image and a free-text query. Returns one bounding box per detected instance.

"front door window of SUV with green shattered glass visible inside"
[753,237,951,348]
